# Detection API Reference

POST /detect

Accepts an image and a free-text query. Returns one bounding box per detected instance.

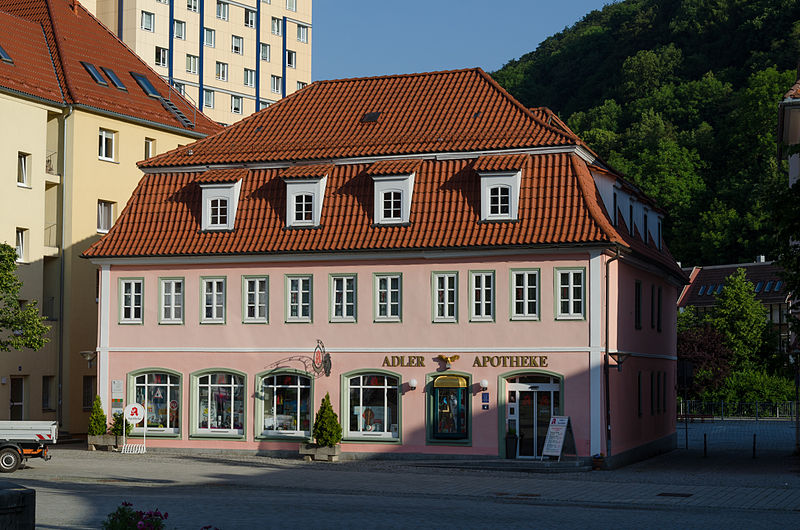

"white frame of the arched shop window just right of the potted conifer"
[342,372,403,441]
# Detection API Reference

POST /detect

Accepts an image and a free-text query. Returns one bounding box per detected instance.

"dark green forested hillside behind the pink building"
[492,0,800,265]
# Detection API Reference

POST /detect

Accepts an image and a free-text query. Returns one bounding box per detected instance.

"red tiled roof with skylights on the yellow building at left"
[0,0,221,135]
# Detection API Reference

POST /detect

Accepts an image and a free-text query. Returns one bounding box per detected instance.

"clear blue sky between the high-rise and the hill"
[311,0,612,81]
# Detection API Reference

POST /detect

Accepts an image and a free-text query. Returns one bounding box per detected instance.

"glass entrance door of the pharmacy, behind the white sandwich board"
[506,376,561,458]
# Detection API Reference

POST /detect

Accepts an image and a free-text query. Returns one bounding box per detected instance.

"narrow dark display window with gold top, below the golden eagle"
[429,375,470,440]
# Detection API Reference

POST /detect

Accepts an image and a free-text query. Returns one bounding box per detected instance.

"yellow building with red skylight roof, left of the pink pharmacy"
[0,0,220,433]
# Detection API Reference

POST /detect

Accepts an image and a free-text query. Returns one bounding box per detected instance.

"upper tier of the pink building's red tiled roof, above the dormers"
[140,68,577,168]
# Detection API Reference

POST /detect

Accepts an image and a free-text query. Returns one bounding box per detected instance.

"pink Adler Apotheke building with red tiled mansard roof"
[85,69,686,465]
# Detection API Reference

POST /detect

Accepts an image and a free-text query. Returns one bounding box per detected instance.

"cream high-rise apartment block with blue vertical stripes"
[86,0,312,124]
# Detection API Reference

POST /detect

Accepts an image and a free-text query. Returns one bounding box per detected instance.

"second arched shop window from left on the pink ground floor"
[194,372,245,435]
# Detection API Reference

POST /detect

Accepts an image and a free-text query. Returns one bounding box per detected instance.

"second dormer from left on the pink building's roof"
[281,164,333,228]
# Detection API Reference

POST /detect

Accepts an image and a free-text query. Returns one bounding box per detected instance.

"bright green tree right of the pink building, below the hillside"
[709,269,767,371]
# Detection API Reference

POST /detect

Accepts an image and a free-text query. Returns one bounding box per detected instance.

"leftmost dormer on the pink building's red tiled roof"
[195,168,247,231]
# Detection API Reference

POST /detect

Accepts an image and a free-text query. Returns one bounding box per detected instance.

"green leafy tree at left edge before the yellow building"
[0,243,49,351]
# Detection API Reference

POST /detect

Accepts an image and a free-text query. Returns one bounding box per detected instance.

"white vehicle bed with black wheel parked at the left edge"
[0,421,58,473]
